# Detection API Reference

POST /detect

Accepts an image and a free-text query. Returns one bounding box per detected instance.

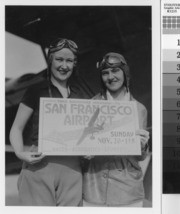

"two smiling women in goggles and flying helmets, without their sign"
[10,39,149,206]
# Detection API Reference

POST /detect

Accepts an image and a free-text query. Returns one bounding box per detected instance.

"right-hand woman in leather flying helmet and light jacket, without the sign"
[83,52,149,207]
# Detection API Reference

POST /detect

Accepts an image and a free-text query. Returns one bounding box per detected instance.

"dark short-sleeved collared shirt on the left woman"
[21,80,83,146]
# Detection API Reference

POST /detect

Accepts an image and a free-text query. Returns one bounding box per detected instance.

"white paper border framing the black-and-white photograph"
[0,0,162,214]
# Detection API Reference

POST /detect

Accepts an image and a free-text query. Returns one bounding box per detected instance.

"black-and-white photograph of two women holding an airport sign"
[4,1,160,213]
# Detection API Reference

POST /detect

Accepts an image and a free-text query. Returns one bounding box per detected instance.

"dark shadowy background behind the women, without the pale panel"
[5,6,152,172]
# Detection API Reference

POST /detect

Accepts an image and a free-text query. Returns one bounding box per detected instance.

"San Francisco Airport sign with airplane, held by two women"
[39,98,141,155]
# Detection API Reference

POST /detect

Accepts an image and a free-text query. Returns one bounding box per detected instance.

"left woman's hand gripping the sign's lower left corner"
[16,151,45,164]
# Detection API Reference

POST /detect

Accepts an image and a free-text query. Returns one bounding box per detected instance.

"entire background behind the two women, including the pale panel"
[5,6,152,206]
